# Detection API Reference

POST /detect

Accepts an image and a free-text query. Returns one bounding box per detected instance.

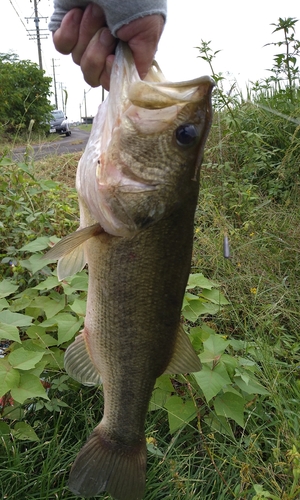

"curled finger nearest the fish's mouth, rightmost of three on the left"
[80,28,117,90]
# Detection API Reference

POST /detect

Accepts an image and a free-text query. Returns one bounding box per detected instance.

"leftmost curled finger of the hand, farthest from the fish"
[53,9,83,54]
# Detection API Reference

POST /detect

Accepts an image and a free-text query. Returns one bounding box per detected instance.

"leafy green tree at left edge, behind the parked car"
[0,53,53,134]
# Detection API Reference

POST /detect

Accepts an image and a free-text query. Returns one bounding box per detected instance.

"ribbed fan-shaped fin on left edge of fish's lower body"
[64,331,102,385]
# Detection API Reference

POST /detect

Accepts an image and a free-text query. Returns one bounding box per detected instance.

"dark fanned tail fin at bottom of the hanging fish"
[68,423,147,500]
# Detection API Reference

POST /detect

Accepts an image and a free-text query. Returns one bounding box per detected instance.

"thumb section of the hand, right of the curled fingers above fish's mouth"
[117,14,164,78]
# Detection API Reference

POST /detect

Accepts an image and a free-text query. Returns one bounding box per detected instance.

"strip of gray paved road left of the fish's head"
[13,128,90,161]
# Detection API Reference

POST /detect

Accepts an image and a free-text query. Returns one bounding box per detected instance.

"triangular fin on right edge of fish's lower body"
[164,326,201,374]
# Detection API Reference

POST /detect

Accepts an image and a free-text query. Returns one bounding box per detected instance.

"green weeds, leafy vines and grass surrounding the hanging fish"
[0,18,300,500]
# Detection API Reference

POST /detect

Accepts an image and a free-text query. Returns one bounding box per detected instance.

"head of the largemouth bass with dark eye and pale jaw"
[77,43,214,236]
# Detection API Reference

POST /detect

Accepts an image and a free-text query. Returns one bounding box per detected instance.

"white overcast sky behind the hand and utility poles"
[0,0,300,120]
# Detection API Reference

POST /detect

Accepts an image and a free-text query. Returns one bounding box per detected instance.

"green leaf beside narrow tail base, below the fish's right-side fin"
[165,396,197,434]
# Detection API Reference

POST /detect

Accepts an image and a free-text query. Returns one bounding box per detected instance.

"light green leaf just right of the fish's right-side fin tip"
[193,364,231,402]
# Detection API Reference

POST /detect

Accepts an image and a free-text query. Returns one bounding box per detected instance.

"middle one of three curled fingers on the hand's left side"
[72,3,106,64]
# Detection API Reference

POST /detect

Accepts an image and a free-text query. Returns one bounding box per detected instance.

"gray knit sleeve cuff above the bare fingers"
[49,0,167,36]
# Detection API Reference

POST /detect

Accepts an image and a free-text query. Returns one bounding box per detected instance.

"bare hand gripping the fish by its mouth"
[53,3,164,90]
